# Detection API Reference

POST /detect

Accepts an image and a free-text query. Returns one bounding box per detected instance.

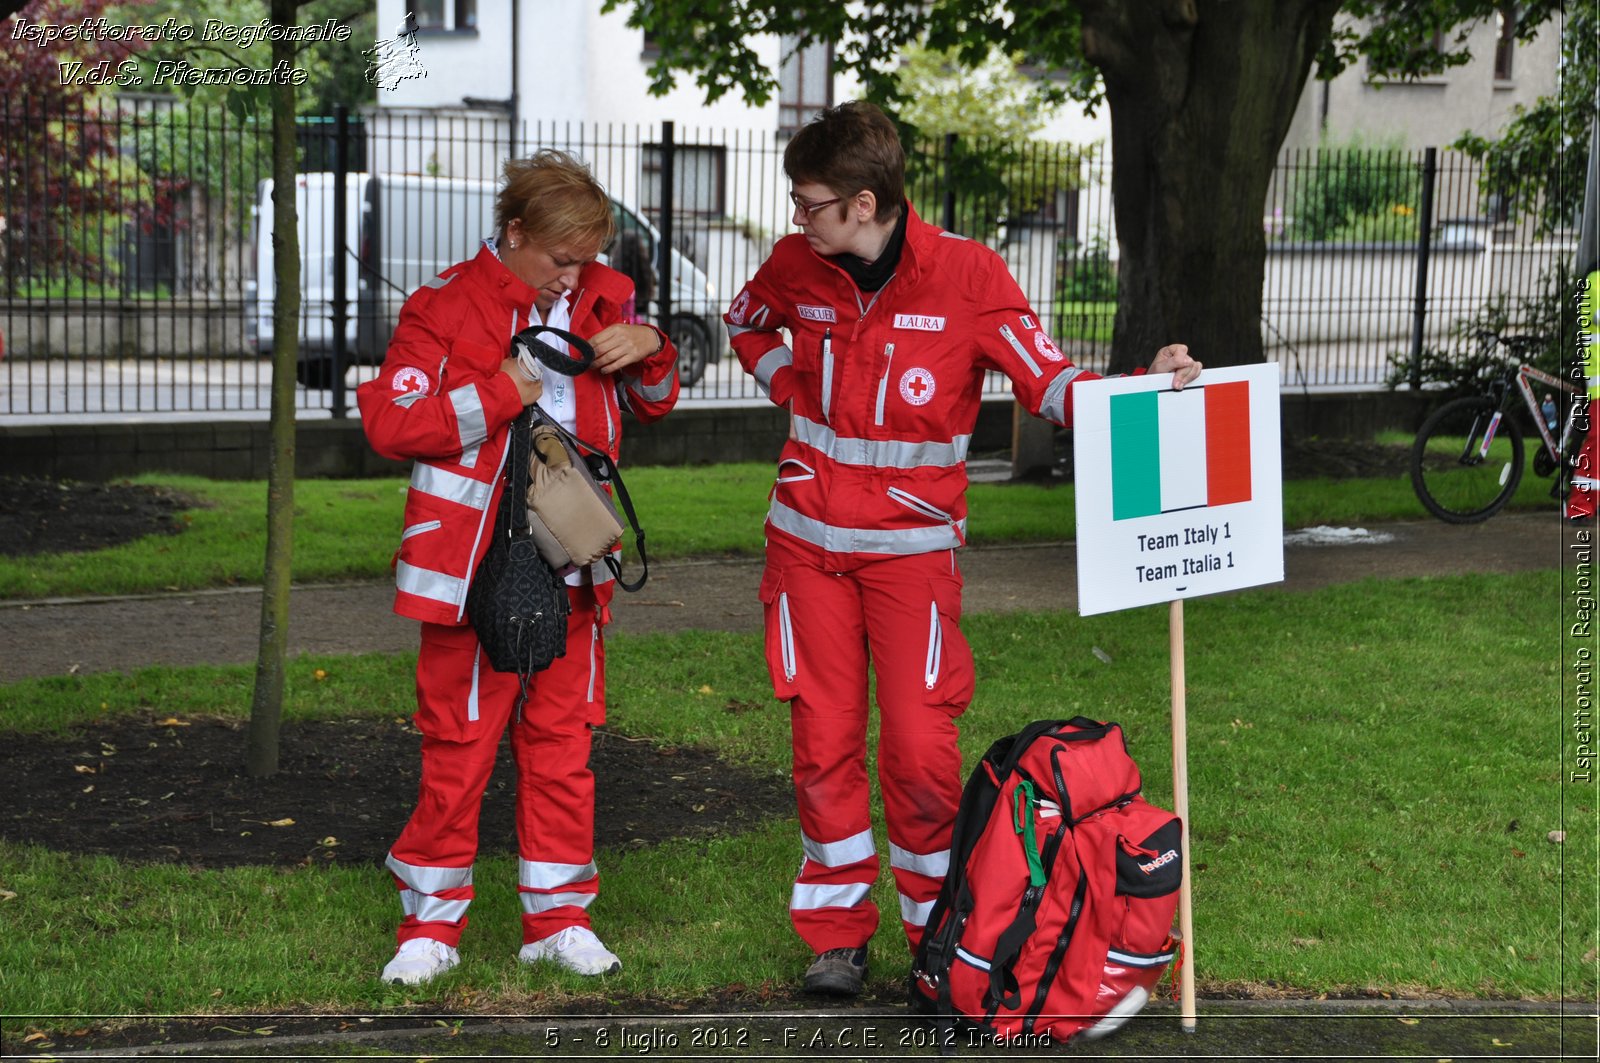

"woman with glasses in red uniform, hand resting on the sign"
[725,102,1200,996]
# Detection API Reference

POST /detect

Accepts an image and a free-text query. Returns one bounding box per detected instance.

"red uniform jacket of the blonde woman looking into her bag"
[355,247,678,624]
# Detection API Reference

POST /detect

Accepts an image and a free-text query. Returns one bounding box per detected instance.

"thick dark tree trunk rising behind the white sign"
[1078,0,1339,371]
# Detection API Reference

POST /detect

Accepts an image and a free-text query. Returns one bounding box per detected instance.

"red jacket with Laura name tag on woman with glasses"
[725,203,1094,565]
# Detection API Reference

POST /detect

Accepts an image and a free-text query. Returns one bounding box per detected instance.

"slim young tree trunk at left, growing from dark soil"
[245,0,301,778]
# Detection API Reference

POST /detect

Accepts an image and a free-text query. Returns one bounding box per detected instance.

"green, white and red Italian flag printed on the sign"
[1110,381,1250,520]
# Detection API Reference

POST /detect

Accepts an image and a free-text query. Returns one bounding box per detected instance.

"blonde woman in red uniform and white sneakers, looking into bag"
[357,150,678,983]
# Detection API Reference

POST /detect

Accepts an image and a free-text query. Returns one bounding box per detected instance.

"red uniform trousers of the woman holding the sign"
[762,530,973,953]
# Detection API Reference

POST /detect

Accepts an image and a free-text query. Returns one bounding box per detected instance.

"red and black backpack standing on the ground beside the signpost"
[910,716,1182,1042]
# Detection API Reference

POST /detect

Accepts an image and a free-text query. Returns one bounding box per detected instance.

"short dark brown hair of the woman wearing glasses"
[784,99,906,221]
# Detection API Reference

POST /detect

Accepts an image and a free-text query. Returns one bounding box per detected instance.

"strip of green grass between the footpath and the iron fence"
[0,463,1552,599]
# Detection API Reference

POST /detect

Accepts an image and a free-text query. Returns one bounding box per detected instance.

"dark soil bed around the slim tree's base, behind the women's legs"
[0,716,794,868]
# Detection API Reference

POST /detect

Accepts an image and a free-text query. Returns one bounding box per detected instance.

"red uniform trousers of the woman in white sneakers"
[387,588,605,945]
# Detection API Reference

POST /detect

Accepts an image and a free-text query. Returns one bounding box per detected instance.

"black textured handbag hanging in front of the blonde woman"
[467,410,573,680]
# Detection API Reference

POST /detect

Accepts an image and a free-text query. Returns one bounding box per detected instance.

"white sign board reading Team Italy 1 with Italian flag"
[1072,363,1283,616]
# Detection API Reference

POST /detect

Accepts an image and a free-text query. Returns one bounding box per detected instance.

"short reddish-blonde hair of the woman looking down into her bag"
[494,147,616,250]
